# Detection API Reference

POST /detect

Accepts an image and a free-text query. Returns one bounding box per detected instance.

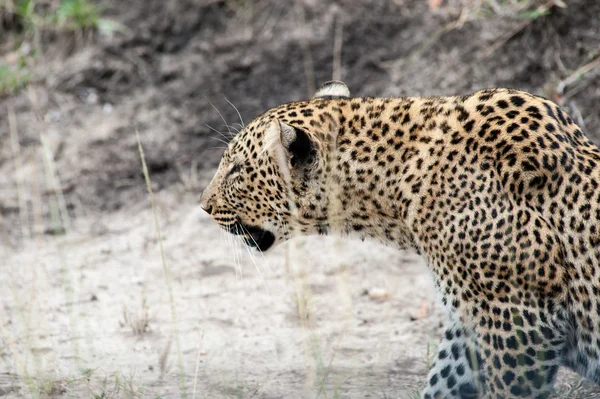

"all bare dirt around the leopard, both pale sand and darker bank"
[0,0,600,399]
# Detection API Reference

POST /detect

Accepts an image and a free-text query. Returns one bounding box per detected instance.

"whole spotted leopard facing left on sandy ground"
[199,81,600,399]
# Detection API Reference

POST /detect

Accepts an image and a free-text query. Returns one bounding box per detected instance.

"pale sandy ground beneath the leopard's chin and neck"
[0,186,600,399]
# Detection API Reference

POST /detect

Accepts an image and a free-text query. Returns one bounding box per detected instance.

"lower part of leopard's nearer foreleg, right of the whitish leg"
[475,303,565,399]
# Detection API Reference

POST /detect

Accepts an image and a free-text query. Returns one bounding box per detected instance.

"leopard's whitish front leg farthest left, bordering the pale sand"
[422,317,483,399]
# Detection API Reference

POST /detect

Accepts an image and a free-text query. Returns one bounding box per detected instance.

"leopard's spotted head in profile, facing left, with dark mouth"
[200,82,349,251]
